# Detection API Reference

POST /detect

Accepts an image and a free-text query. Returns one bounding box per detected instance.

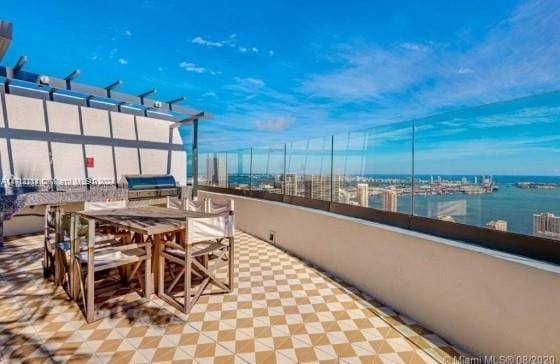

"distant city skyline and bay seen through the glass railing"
[203,173,560,240]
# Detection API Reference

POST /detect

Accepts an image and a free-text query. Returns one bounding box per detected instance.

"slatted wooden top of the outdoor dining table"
[77,206,220,235]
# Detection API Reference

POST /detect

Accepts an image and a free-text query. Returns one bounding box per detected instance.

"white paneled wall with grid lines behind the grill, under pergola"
[0,94,186,184]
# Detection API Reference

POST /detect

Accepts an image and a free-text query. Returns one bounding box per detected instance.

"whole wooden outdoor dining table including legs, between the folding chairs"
[70,206,232,298]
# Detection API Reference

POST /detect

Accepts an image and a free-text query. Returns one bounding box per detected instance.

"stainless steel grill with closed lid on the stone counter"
[119,174,181,201]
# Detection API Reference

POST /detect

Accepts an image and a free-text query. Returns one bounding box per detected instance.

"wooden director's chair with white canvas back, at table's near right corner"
[158,201,234,313]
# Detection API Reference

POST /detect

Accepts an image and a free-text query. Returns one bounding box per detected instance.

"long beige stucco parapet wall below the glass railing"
[199,192,560,358]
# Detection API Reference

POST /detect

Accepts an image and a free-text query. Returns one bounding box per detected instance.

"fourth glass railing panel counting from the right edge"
[251,144,284,193]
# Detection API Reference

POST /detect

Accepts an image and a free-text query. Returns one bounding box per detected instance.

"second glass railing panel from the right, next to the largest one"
[333,122,412,213]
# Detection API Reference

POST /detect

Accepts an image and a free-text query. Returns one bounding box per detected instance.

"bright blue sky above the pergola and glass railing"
[1,0,560,173]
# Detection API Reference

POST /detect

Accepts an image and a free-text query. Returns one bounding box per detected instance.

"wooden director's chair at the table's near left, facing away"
[72,216,152,322]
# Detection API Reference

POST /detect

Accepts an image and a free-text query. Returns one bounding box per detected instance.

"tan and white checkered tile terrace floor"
[0,232,464,363]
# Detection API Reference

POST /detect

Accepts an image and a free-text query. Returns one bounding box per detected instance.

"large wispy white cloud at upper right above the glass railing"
[301,0,560,118]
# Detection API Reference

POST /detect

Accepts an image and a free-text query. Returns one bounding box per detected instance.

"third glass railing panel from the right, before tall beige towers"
[282,136,336,200]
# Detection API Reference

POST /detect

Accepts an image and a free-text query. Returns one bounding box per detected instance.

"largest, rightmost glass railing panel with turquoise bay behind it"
[414,92,560,239]
